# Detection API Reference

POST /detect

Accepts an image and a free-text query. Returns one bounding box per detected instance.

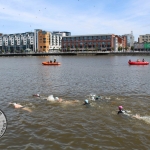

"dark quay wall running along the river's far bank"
[0,51,150,57]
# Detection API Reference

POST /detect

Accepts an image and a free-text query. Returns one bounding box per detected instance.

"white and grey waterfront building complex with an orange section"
[0,29,71,53]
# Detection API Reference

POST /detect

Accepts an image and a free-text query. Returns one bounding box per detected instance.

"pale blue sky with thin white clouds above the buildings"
[0,0,150,41]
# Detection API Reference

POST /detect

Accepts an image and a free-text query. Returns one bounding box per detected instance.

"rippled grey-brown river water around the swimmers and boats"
[0,56,150,150]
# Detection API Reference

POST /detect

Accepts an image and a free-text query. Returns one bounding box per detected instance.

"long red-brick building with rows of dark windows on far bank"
[61,34,126,51]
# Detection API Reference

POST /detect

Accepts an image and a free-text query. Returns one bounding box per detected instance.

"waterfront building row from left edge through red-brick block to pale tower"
[0,29,134,53]
